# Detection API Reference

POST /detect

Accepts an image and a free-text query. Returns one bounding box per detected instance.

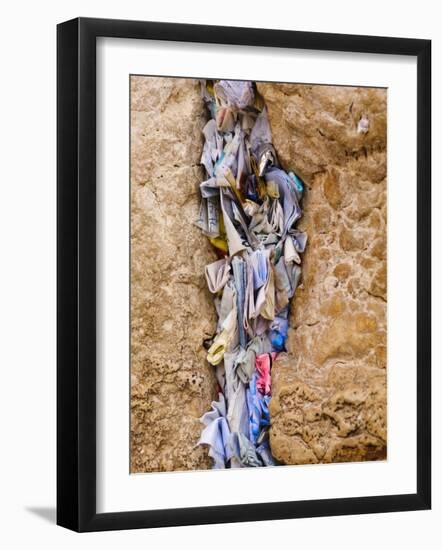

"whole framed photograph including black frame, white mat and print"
[57,18,431,531]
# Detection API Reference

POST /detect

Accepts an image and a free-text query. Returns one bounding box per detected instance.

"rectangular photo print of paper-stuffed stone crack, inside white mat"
[129,75,387,474]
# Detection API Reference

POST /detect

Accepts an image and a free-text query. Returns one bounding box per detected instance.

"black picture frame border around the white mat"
[57,18,431,531]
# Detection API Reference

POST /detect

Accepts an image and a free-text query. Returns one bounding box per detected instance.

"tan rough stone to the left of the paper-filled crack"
[131,77,216,473]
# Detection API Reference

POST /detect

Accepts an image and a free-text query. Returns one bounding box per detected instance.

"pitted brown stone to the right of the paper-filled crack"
[258,83,387,464]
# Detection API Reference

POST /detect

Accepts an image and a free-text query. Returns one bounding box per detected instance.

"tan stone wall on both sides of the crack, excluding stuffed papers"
[131,77,386,473]
